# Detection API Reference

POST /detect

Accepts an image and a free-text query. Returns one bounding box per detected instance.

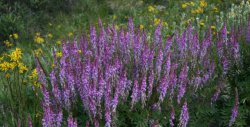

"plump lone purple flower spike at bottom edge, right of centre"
[178,101,189,127]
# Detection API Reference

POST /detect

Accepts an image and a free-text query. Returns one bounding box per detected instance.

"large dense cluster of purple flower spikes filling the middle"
[37,19,240,127]
